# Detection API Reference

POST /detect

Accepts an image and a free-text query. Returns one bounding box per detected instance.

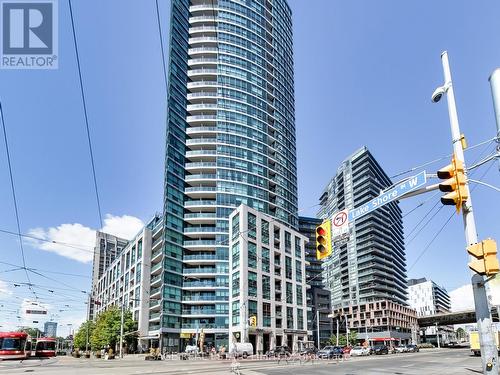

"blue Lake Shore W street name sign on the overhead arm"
[349,171,426,221]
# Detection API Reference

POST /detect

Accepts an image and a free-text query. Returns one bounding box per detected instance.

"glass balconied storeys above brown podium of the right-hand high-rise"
[318,147,407,312]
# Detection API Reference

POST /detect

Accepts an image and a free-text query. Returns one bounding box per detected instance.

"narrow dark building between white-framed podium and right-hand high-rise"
[299,216,333,348]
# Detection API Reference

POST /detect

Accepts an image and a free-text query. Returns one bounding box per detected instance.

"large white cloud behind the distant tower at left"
[28,214,144,263]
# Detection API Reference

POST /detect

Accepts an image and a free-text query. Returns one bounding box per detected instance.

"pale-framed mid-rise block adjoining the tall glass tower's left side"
[92,216,163,349]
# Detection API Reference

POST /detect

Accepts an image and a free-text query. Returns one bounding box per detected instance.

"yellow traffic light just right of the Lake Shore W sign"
[437,156,469,213]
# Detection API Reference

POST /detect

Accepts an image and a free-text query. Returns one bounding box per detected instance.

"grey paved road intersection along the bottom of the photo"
[0,349,481,375]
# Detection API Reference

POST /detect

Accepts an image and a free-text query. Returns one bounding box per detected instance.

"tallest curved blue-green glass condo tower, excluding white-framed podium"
[160,0,298,349]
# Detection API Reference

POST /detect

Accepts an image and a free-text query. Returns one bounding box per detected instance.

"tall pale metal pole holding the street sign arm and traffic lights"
[436,51,499,375]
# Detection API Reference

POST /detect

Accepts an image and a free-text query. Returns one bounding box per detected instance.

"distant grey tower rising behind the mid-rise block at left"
[87,231,128,320]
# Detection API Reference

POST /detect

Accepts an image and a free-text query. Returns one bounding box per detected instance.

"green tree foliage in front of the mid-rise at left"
[90,306,137,350]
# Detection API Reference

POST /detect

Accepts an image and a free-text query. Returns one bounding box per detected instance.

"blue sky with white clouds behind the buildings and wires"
[0,0,500,335]
